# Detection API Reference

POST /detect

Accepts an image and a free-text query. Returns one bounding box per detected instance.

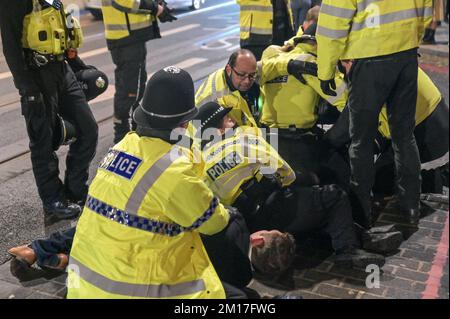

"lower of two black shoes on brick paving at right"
[334,248,385,268]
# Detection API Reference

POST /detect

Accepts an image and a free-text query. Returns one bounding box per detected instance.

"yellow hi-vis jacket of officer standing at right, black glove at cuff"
[316,0,432,80]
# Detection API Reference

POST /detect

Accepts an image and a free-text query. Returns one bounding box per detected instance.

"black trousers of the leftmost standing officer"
[22,62,98,204]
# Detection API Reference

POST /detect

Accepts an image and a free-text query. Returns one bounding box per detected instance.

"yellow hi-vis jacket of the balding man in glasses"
[195,69,258,127]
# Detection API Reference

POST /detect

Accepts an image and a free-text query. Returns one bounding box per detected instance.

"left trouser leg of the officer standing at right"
[348,60,396,227]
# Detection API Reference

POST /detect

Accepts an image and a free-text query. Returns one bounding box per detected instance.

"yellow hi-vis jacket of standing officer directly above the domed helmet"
[102,0,156,40]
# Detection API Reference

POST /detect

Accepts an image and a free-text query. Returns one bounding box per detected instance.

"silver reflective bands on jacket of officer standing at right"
[317,5,432,39]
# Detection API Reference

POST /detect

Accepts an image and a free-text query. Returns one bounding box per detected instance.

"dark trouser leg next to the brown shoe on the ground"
[31,227,75,267]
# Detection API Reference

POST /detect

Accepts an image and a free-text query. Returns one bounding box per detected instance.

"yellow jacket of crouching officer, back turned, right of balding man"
[260,43,348,129]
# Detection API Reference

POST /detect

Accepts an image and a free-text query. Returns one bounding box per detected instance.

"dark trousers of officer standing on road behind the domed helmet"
[111,42,147,143]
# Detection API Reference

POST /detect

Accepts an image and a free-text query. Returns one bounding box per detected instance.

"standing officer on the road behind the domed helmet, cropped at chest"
[102,0,177,143]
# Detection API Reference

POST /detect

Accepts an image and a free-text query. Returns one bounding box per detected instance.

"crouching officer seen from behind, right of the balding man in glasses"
[260,24,347,175]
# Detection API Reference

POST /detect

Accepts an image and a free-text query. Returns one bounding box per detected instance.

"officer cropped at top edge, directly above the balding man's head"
[237,0,295,61]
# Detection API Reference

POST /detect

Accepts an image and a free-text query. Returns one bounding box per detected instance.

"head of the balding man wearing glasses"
[225,49,257,92]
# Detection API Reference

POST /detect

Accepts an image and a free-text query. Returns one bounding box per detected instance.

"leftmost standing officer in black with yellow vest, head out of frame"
[0,0,97,218]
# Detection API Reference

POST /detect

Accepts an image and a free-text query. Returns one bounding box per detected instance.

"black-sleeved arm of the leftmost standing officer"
[0,1,40,96]
